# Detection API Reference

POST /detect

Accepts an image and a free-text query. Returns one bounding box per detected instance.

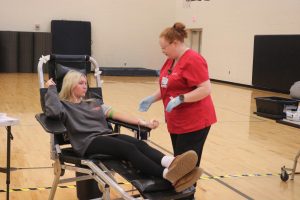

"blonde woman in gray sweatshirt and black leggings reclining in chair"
[45,70,201,192]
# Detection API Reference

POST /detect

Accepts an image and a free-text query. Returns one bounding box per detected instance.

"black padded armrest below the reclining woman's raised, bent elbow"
[35,113,67,134]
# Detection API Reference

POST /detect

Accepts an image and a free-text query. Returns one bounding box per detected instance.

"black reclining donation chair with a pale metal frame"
[35,55,195,200]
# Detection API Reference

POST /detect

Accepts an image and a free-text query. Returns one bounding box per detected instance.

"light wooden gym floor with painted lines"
[0,73,300,200]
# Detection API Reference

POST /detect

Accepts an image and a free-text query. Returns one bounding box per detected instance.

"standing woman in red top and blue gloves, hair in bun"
[139,23,217,173]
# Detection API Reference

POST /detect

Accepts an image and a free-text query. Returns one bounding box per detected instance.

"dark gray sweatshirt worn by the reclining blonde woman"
[45,86,112,156]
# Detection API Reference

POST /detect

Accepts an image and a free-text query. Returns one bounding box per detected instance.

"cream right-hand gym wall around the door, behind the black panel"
[176,0,300,85]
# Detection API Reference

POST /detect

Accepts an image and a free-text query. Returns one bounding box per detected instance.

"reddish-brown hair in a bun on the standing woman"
[159,22,187,43]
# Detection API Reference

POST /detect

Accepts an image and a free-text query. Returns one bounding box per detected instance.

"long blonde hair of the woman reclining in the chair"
[59,70,86,101]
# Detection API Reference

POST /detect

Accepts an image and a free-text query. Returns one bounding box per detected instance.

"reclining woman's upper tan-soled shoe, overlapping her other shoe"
[166,150,198,184]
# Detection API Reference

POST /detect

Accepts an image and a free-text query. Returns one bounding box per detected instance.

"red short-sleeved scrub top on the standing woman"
[159,50,217,134]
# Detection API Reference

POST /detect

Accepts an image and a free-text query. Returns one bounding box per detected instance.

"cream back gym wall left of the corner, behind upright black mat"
[0,0,175,69]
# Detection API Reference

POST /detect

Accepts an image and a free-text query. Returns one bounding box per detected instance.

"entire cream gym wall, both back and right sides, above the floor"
[0,0,300,85]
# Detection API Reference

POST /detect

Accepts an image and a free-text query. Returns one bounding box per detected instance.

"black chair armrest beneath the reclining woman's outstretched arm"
[107,118,151,140]
